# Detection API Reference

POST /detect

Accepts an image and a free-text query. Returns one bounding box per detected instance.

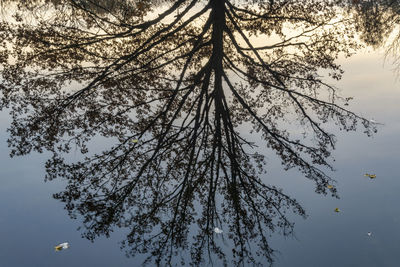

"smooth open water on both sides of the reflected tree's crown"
[0,51,400,267]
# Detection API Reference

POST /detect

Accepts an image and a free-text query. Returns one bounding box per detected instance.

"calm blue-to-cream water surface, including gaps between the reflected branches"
[0,0,400,267]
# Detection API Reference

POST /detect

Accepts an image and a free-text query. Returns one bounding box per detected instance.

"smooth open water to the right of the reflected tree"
[268,49,400,266]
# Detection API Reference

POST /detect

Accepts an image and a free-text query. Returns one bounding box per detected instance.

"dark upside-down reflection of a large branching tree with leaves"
[1,0,374,266]
